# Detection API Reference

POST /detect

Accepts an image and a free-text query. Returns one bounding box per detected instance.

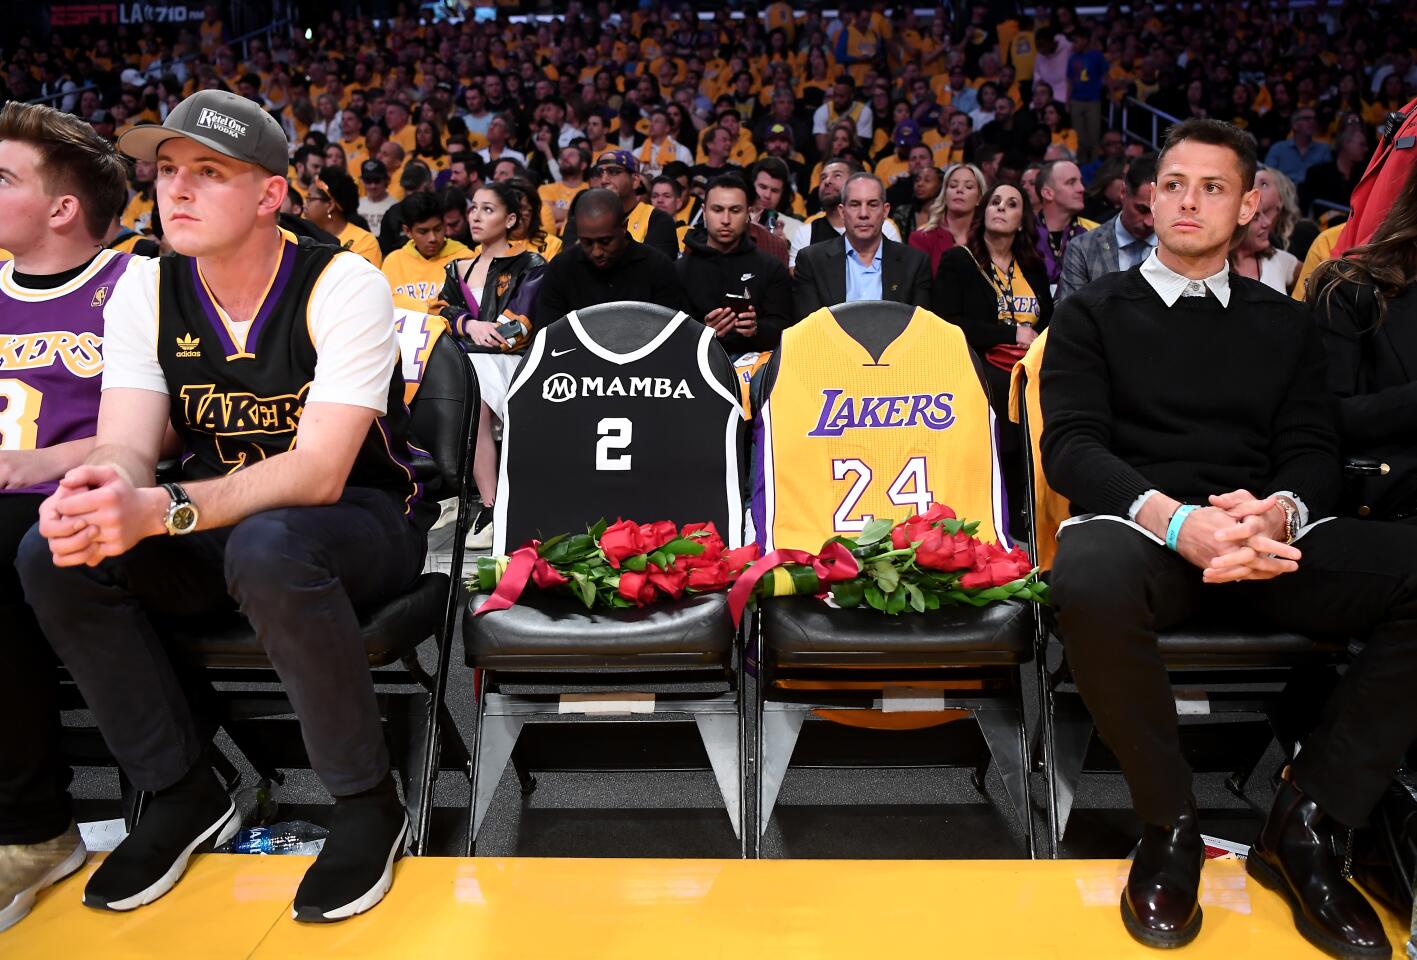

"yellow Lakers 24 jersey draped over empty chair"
[752,308,1007,552]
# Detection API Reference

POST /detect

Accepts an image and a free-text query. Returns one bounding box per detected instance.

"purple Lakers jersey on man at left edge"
[0,250,129,493]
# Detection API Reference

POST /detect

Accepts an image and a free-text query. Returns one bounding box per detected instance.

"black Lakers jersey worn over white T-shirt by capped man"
[157,231,421,510]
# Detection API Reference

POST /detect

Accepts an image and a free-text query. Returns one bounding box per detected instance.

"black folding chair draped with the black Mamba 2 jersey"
[462,302,745,856]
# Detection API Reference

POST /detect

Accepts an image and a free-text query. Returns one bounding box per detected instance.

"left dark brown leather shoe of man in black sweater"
[1122,803,1206,950]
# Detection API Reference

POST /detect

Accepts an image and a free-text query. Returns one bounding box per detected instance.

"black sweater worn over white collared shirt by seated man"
[1040,268,1342,518]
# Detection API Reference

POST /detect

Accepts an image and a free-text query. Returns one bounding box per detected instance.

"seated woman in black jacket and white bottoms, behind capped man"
[439,182,546,549]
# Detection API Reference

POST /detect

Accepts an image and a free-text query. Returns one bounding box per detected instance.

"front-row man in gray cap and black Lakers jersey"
[16,91,436,922]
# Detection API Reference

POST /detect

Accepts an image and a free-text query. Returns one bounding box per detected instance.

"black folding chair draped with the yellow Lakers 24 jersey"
[750,301,1036,856]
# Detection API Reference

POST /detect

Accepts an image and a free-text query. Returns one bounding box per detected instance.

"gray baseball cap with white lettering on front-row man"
[118,89,290,177]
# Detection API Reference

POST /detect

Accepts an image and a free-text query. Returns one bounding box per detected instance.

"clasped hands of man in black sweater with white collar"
[1136,489,1304,583]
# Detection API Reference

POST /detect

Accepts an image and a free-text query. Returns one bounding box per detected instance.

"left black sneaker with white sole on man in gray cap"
[84,761,241,910]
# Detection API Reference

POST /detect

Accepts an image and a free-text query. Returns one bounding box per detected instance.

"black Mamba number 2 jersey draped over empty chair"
[493,306,743,553]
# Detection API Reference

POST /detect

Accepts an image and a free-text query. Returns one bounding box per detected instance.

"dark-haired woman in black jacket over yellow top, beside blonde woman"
[931,183,1053,533]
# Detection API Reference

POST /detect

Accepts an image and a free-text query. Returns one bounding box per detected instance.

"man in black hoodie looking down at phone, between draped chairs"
[674,173,798,356]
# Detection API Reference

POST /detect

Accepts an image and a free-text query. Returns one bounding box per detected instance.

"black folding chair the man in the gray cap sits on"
[81,336,480,854]
